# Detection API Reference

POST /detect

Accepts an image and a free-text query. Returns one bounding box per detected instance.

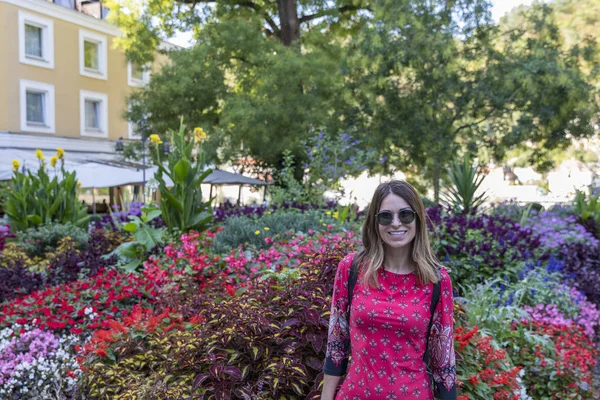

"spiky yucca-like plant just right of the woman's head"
[445,156,486,214]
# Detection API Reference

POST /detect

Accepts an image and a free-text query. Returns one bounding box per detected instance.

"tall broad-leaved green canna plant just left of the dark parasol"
[150,120,212,233]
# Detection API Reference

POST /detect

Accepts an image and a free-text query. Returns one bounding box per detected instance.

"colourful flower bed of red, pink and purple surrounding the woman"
[0,202,600,400]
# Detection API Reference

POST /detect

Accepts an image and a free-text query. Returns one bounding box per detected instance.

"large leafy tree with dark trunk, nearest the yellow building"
[108,0,369,175]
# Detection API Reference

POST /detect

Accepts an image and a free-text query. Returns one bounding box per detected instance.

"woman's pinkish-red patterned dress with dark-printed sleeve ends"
[324,254,456,400]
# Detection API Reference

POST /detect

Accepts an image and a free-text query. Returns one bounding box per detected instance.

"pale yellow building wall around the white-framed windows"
[0,0,165,140]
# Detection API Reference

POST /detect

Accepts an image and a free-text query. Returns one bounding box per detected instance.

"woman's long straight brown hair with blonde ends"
[356,180,442,287]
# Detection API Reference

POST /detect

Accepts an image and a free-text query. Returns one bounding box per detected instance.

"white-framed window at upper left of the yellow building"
[19,11,54,69]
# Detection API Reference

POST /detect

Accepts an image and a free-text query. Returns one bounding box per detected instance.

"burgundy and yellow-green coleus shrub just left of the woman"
[76,245,347,399]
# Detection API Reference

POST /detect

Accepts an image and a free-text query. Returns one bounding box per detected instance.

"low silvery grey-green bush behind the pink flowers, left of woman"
[213,210,336,253]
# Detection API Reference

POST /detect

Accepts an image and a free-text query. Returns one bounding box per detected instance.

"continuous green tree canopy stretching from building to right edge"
[110,0,598,199]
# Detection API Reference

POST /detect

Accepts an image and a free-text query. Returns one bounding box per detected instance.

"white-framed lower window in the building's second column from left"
[80,90,108,138]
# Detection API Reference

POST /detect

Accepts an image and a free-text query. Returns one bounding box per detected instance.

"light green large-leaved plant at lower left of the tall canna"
[111,206,164,272]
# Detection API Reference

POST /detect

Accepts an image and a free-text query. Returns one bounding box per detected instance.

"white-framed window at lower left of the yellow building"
[19,80,55,133]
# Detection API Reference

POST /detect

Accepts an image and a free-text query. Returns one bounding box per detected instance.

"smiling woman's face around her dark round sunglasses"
[377,193,417,248]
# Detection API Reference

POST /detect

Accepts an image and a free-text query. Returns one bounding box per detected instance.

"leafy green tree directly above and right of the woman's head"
[349,0,598,200]
